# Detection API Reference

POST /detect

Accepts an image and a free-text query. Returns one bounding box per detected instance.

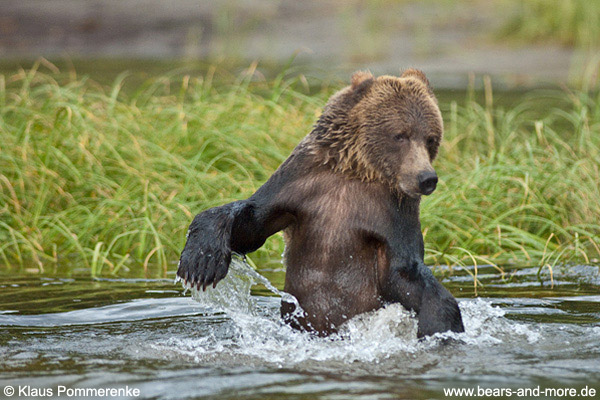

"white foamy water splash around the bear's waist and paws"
[166,258,541,365]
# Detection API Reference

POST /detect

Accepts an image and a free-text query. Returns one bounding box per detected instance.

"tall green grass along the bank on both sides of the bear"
[0,63,600,282]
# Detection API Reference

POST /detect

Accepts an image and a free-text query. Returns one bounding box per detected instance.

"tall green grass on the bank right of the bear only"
[422,82,600,282]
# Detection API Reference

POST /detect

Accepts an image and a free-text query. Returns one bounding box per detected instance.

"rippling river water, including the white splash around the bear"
[0,262,600,399]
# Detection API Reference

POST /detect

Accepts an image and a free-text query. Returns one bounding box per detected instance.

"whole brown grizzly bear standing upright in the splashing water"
[177,69,464,337]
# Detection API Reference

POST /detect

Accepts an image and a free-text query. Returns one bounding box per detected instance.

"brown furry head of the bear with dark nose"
[313,69,443,197]
